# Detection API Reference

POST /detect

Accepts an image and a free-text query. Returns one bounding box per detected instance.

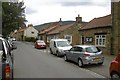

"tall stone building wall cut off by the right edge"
[111,1,120,54]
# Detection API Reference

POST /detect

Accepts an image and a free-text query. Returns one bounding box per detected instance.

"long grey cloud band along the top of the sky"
[56,0,110,7]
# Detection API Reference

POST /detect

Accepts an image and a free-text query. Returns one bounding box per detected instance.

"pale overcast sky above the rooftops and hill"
[24,0,111,26]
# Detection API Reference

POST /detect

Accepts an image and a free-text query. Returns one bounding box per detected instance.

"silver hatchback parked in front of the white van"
[64,45,104,67]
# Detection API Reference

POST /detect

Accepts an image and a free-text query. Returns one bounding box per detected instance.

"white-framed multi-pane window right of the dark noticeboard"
[95,35,106,47]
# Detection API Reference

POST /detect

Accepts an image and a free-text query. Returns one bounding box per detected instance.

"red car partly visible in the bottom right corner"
[109,54,120,79]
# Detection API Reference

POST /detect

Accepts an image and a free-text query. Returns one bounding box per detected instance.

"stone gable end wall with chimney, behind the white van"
[60,15,86,45]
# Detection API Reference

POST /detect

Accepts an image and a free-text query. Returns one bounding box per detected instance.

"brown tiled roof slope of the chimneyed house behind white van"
[48,24,73,35]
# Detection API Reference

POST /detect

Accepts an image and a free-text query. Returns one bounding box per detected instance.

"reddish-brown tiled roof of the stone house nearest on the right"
[80,15,112,30]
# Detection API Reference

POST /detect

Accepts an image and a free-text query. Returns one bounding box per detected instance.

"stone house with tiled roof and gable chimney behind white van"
[47,15,85,45]
